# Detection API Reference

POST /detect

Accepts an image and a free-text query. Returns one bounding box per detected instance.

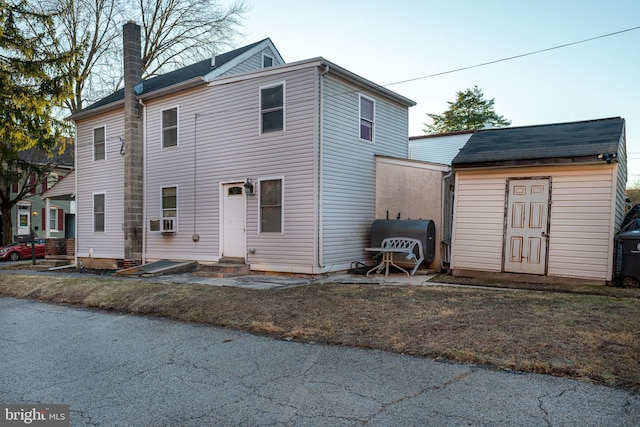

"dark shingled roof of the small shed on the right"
[452,117,625,168]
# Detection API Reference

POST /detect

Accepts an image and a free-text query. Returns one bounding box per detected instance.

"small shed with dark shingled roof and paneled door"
[451,118,627,284]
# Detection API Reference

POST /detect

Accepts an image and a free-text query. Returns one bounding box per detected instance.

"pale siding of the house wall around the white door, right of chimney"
[145,68,318,273]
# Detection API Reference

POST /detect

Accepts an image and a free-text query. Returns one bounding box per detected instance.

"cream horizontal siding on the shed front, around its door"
[452,165,615,280]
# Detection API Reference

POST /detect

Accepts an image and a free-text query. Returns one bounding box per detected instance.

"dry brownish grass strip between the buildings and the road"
[0,275,640,391]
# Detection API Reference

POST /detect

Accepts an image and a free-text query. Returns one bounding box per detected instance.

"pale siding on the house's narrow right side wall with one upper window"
[320,74,408,269]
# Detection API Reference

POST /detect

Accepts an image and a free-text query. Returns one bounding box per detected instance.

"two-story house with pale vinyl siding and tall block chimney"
[70,23,414,274]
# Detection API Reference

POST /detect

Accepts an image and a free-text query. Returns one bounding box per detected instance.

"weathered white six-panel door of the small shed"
[504,178,549,274]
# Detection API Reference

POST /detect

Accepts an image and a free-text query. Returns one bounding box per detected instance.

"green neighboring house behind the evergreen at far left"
[4,145,73,241]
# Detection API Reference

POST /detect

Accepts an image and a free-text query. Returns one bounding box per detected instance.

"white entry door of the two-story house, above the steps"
[222,183,247,258]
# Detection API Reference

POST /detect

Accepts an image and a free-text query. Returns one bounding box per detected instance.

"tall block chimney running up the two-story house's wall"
[123,21,144,268]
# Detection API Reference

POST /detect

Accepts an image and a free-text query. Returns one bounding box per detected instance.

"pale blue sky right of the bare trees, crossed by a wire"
[236,0,640,184]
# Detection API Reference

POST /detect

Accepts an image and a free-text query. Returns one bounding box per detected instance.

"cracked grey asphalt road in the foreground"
[0,298,640,426]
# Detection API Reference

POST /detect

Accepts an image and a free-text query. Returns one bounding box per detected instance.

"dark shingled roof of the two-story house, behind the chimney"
[83,39,267,111]
